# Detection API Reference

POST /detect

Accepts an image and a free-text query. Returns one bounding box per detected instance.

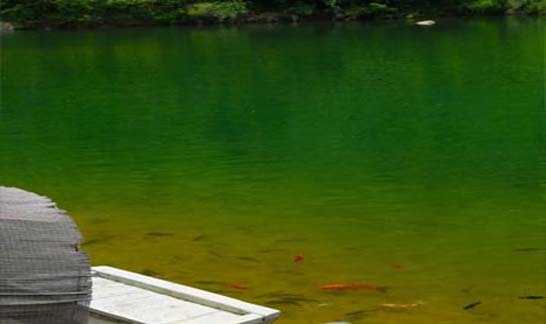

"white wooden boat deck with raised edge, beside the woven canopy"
[89,266,280,324]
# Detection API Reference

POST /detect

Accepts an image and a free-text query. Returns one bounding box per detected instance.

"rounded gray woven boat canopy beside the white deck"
[0,187,91,324]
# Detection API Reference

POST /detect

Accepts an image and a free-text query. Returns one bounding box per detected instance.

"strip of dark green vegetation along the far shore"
[0,0,546,28]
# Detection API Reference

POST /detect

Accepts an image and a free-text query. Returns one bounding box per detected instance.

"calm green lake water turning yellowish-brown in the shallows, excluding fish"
[0,18,546,324]
